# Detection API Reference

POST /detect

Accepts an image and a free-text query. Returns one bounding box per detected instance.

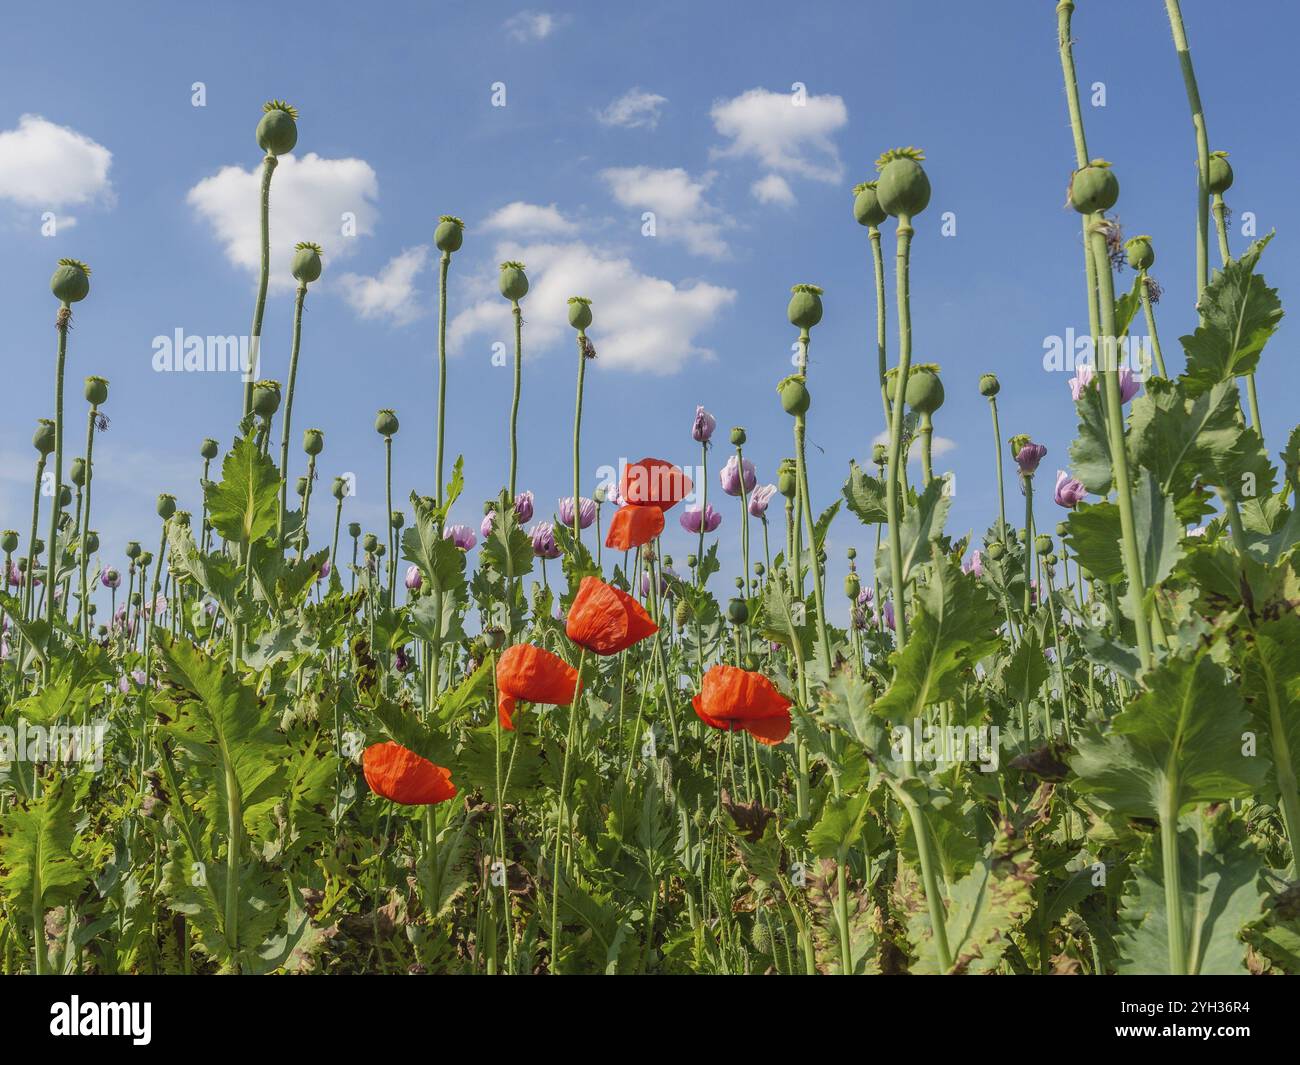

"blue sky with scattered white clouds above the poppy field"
[0,0,1300,616]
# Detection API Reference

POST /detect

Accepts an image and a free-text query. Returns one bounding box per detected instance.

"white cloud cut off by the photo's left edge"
[0,114,113,209]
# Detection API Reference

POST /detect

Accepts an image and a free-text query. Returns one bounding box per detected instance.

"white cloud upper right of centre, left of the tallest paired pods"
[710,88,849,182]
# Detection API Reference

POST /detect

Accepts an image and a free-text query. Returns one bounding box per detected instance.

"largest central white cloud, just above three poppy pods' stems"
[449,241,736,375]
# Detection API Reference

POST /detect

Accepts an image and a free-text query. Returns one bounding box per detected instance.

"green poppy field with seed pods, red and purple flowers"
[0,0,1300,975]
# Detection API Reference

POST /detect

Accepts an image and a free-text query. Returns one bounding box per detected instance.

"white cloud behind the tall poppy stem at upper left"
[186,152,380,287]
